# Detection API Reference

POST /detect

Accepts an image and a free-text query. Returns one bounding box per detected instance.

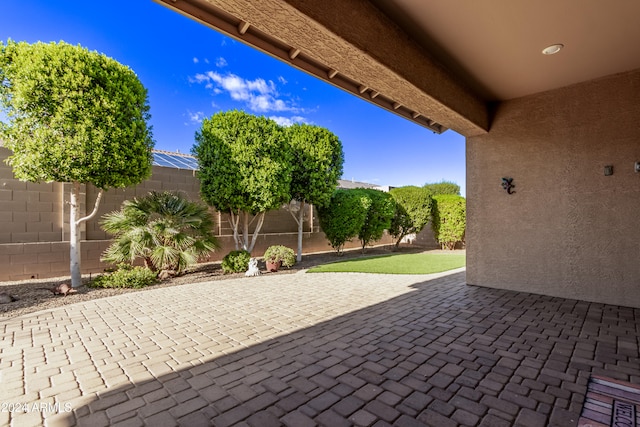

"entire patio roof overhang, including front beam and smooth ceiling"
[155,0,640,137]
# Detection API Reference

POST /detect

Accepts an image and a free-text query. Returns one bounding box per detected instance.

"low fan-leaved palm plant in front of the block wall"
[100,191,219,274]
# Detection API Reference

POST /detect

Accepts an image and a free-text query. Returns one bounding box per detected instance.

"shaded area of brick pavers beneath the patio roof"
[60,272,640,427]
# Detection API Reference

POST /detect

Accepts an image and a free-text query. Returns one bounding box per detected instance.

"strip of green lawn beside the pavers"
[308,252,466,274]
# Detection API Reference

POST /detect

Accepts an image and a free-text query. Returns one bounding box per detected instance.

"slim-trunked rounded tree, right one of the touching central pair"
[287,124,344,261]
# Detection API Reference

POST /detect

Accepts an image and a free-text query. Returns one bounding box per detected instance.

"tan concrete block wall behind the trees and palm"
[0,147,424,281]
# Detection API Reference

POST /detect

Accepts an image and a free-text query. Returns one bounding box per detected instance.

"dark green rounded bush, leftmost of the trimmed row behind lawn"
[318,189,370,253]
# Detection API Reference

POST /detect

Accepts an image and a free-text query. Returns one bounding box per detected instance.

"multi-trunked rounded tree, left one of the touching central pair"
[192,110,291,252]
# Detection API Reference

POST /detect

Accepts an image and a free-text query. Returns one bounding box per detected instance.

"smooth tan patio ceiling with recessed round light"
[372,0,640,100]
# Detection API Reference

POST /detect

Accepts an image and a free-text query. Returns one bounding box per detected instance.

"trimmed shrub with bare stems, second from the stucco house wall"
[389,186,433,248]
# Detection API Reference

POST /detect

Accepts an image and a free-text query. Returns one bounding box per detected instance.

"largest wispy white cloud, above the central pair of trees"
[190,71,301,113]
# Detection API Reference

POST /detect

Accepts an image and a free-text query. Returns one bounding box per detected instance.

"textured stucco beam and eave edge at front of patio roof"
[156,0,489,136]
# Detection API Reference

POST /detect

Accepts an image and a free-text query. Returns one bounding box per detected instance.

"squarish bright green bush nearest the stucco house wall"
[431,195,467,250]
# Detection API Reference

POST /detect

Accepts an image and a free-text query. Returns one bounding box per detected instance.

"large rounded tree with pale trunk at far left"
[0,40,153,287]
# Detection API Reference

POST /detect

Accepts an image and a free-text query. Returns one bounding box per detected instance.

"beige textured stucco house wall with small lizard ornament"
[466,70,640,307]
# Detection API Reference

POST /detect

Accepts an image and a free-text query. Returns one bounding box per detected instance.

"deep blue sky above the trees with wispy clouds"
[0,0,465,195]
